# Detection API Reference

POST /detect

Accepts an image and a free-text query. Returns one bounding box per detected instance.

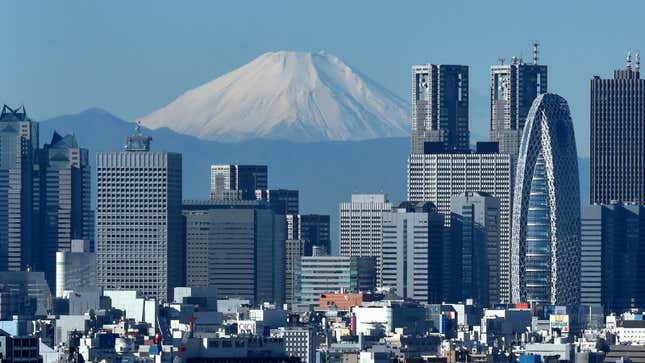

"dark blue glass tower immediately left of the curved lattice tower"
[449,192,500,306]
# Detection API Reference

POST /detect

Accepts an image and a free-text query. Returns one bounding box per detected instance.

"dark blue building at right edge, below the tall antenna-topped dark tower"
[580,204,645,313]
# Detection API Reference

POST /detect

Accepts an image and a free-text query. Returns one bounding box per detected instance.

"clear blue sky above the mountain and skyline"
[0,0,645,155]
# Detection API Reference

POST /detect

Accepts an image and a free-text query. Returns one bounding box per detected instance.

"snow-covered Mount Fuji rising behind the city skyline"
[138,51,410,142]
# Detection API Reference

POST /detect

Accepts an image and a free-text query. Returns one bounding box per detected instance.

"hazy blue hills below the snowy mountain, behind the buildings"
[40,109,589,252]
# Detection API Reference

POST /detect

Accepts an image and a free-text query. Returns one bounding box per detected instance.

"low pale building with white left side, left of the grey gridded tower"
[55,239,97,298]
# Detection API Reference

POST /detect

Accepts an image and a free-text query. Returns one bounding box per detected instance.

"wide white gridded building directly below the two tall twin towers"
[408,150,512,302]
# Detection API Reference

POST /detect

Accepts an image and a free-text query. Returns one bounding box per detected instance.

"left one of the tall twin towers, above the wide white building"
[412,64,470,154]
